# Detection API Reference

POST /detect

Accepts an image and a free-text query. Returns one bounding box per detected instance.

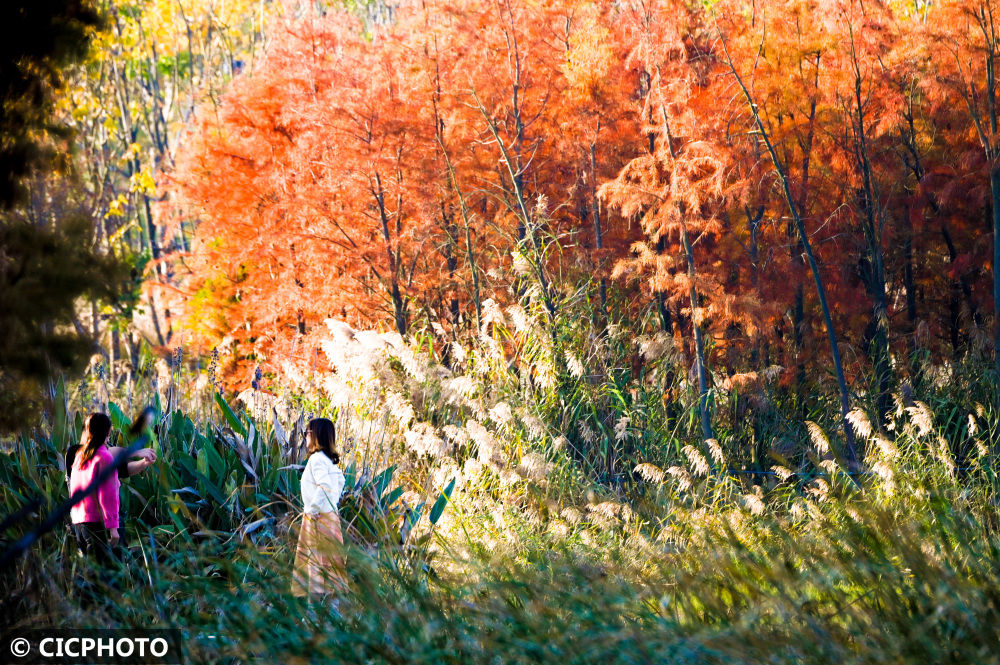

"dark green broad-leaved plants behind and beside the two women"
[0,382,440,568]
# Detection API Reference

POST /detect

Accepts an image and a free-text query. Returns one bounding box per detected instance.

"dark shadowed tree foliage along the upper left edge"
[0,0,120,431]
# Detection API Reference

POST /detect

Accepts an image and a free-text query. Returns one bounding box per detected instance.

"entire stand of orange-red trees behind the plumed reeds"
[169,0,1000,440]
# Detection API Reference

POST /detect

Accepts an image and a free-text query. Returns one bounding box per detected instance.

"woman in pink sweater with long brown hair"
[69,413,121,562]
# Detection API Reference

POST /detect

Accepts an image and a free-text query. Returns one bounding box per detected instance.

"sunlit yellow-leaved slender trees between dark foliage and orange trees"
[47,0,280,366]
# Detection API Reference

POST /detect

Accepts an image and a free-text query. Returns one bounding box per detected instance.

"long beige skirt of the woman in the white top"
[292,512,347,596]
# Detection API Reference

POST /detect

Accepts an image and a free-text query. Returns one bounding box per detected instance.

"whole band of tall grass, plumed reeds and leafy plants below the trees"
[0,268,1000,663]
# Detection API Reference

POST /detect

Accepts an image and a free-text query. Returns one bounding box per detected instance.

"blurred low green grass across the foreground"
[3,478,1000,663]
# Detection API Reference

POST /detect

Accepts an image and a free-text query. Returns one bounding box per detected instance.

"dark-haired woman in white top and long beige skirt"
[292,418,347,596]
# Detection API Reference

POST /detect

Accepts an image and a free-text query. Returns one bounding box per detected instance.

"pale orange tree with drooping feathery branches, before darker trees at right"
[601,2,756,439]
